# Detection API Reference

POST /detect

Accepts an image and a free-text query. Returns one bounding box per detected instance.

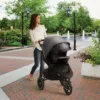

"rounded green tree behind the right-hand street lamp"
[57,1,92,32]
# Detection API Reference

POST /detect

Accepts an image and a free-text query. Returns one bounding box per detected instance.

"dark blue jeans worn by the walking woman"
[30,48,44,77]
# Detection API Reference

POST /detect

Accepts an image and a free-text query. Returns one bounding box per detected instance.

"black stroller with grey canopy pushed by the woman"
[37,36,73,95]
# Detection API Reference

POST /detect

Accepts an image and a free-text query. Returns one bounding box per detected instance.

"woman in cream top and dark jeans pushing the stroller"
[29,14,47,80]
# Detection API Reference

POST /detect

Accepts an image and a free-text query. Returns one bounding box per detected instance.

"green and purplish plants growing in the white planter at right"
[76,38,100,65]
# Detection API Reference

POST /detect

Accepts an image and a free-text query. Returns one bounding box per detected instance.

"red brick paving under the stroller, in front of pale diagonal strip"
[2,48,100,100]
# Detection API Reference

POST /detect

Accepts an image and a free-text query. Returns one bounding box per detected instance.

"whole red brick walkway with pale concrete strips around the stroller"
[0,42,100,100]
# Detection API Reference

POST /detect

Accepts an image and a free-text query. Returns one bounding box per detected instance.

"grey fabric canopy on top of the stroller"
[42,36,71,57]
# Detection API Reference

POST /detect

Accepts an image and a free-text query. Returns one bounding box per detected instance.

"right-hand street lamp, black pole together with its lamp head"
[66,7,76,50]
